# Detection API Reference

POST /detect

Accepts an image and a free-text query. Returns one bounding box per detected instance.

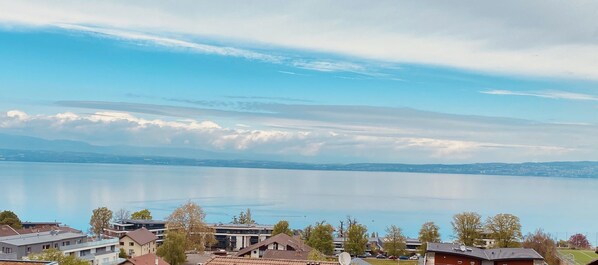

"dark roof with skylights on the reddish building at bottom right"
[427,243,544,260]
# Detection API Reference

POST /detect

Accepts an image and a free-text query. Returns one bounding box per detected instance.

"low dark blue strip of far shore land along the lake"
[0,149,598,178]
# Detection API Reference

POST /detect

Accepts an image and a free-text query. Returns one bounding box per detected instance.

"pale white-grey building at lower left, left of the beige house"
[58,238,121,265]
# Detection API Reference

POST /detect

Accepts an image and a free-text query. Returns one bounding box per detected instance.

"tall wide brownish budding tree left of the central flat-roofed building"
[166,201,216,252]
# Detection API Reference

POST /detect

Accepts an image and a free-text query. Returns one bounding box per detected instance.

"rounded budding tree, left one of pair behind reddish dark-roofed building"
[451,212,482,246]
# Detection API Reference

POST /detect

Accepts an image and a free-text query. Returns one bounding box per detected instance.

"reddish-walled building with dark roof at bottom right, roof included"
[424,243,544,265]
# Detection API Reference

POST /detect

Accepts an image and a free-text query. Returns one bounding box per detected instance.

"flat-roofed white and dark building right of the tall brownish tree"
[208,224,274,251]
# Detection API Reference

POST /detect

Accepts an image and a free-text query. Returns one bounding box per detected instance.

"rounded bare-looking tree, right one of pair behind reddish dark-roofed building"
[486,213,523,248]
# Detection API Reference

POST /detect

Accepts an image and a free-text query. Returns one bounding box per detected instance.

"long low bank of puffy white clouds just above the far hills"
[0,110,596,163]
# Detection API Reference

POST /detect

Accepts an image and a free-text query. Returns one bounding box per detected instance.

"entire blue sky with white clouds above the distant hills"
[0,0,598,164]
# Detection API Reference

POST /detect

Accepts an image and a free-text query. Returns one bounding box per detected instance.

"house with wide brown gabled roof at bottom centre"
[237,234,311,258]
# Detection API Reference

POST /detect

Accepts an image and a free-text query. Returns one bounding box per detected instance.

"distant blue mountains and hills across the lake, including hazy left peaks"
[0,134,598,178]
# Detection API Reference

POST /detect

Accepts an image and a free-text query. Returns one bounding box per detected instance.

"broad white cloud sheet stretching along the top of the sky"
[0,0,598,79]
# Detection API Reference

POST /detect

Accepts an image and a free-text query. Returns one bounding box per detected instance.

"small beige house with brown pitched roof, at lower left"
[120,227,158,257]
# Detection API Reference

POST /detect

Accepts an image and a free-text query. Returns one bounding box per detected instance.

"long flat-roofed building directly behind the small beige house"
[104,219,167,245]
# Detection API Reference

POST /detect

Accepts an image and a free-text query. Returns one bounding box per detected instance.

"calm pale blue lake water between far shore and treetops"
[0,162,598,241]
